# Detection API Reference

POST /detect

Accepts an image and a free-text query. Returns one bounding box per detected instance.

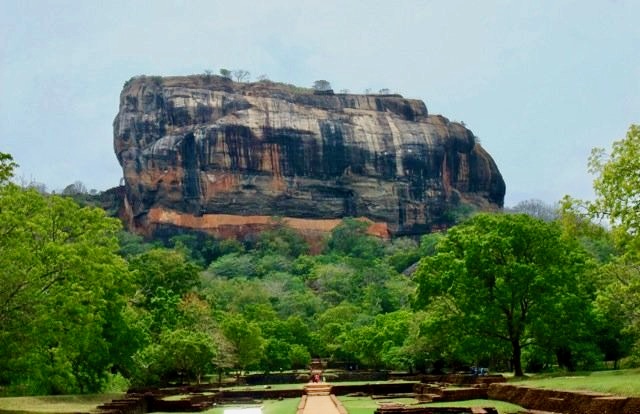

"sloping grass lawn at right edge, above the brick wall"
[509,369,640,397]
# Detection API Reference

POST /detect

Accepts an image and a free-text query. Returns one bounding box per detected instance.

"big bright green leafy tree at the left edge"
[0,184,136,393]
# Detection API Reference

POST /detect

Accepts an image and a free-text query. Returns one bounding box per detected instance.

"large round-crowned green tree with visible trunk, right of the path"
[416,214,589,376]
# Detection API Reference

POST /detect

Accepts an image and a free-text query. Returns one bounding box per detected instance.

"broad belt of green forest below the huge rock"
[0,126,640,395]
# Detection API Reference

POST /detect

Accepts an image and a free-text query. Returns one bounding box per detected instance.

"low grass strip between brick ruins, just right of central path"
[338,397,523,414]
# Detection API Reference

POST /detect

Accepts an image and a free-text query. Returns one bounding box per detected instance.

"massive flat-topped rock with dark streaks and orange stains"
[114,76,505,235]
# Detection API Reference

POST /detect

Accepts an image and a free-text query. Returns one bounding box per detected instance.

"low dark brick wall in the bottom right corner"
[488,384,640,414]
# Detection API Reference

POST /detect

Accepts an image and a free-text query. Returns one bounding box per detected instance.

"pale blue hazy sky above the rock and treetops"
[0,0,640,206]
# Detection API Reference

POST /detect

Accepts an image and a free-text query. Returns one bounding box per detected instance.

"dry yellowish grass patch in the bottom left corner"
[0,394,123,414]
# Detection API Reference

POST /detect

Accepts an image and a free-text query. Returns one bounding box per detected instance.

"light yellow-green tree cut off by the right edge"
[563,125,640,360]
